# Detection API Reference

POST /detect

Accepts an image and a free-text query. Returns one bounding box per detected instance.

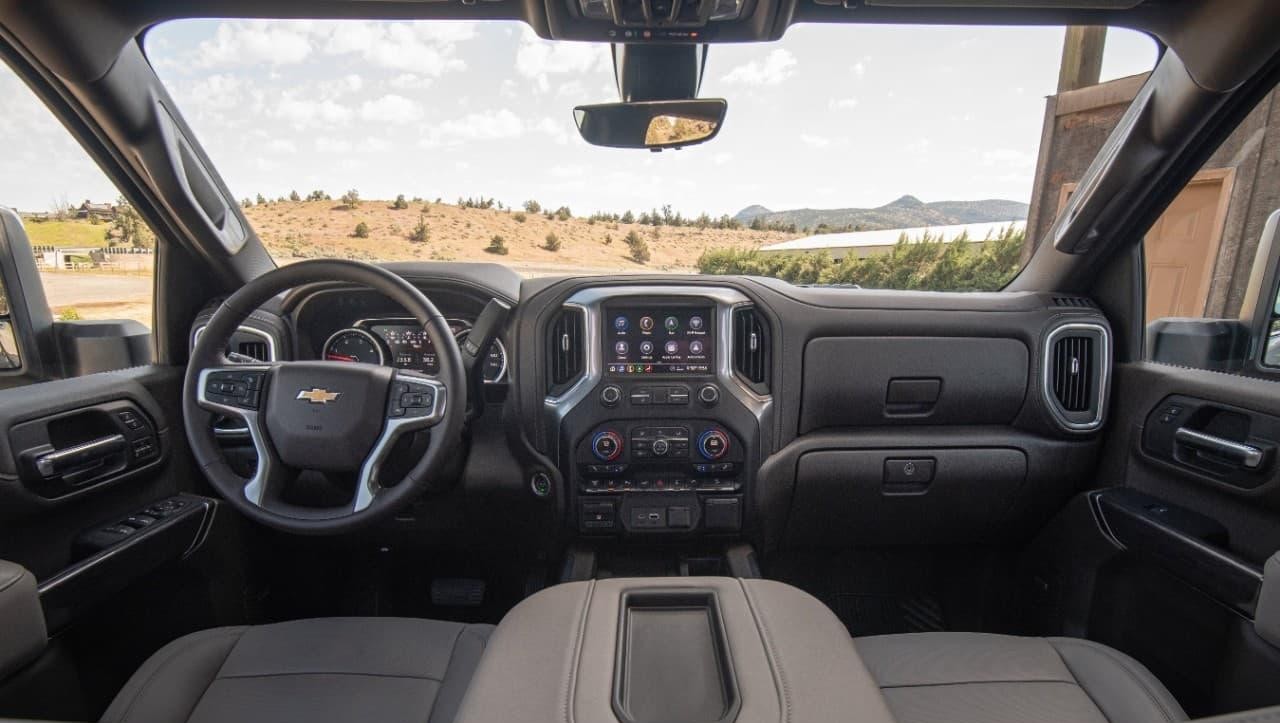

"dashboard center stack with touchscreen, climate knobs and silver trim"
[547,287,772,536]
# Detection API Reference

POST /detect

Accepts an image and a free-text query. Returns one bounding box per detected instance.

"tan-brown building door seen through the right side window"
[1059,169,1235,322]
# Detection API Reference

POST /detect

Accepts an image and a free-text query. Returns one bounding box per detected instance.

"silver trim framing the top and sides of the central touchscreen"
[543,284,773,426]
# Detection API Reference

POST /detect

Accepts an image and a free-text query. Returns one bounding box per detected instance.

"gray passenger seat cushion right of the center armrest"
[855,632,1187,723]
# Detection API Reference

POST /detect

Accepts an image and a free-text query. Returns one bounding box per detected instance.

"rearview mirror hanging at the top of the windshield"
[573,99,728,151]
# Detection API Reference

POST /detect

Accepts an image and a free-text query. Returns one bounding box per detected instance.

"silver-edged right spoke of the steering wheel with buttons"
[351,371,448,512]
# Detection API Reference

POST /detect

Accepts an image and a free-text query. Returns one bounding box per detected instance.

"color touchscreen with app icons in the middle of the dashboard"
[604,307,716,376]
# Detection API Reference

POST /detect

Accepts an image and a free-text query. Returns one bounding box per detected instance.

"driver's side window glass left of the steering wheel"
[0,64,155,328]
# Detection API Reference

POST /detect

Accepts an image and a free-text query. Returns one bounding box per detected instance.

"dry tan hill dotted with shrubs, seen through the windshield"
[244,201,796,273]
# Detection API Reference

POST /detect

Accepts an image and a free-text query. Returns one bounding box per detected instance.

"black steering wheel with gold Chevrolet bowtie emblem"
[183,260,467,535]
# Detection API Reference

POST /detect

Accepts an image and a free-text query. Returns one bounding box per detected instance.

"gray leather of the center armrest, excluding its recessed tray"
[458,577,893,723]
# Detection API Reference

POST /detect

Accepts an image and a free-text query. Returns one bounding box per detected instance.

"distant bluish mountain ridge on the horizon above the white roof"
[733,196,1030,230]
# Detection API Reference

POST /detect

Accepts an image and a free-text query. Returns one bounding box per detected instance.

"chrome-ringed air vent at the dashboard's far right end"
[1044,322,1111,431]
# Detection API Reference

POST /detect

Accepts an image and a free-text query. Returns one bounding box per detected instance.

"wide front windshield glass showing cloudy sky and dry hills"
[146,20,1156,290]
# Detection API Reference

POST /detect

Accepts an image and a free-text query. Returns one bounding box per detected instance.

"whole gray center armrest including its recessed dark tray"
[456,577,893,723]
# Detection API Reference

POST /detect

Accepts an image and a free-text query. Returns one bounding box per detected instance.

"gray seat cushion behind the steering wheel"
[102,618,493,723]
